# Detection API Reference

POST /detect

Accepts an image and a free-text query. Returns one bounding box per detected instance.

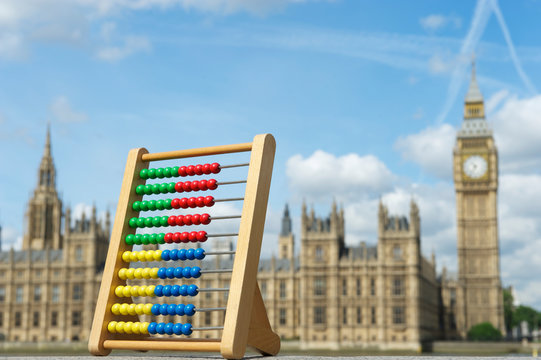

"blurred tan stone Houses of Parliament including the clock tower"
[0,65,504,349]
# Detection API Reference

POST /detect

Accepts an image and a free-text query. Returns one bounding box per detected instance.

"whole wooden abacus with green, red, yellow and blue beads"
[88,134,280,359]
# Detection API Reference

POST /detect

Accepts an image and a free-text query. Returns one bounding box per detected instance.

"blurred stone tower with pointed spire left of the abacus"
[22,127,63,250]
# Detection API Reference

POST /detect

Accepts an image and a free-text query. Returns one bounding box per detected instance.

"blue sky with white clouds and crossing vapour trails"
[0,0,541,308]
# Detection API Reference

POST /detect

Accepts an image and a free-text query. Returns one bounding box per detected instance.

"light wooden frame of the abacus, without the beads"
[88,134,280,359]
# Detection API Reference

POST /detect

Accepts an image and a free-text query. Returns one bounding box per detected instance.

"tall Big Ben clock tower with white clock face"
[453,63,505,338]
